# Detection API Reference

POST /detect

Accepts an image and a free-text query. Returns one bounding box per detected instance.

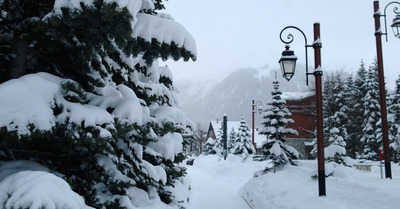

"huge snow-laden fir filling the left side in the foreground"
[0,0,196,208]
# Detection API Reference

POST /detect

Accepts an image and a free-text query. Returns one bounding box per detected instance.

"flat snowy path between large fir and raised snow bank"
[186,159,262,209]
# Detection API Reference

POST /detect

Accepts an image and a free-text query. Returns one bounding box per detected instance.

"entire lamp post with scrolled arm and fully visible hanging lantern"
[279,23,326,196]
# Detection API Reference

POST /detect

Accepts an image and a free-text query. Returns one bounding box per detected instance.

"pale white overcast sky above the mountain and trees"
[165,0,400,89]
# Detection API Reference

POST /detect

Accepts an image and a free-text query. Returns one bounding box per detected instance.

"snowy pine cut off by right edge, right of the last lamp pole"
[388,76,400,163]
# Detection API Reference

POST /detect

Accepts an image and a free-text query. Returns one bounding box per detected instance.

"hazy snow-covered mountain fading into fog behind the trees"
[175,66,313,130]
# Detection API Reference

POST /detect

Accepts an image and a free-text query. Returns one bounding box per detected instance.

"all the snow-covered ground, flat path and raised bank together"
[186,155,400,209]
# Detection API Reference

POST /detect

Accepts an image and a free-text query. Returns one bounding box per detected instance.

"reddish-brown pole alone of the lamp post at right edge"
[374,1,392,178]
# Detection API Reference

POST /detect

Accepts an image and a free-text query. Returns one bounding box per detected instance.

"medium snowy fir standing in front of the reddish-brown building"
[260,81,299,166]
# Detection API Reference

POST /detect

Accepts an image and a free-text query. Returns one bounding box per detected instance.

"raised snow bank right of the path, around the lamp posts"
[240,160,400,209]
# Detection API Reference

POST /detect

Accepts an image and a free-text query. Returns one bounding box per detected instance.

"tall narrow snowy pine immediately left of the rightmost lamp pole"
[361,61,382,160]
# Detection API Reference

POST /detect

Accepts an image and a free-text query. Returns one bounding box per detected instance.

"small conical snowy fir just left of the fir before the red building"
[230,117,256,160]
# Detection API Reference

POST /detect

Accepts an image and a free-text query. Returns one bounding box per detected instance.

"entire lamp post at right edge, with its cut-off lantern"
[374,1,400,178]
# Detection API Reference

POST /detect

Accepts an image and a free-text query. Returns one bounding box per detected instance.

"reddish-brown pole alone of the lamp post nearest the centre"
[313,23,326,196]
